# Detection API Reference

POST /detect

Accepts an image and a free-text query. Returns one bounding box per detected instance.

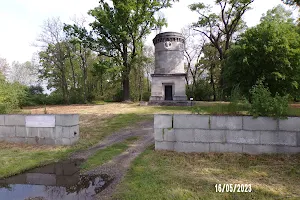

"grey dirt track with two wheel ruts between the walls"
[71,120,154,200]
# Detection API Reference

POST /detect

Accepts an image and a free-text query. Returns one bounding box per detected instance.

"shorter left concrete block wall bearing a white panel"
[0,114,79,145]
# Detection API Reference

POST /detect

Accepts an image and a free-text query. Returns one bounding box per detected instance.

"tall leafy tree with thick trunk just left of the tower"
[67,0,177,100]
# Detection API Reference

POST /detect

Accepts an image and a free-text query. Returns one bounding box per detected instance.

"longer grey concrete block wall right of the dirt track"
[154,114,300,154]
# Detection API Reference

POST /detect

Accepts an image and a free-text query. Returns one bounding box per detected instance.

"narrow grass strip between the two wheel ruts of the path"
[80,136,138,172]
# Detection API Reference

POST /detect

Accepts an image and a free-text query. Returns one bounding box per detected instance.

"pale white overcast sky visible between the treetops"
[0,0,298,63]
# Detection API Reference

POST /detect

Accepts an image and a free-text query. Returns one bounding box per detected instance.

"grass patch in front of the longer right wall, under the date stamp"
[114,147,300,200]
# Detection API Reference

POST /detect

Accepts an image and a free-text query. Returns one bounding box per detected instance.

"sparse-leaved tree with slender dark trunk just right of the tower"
[190,0,253,94]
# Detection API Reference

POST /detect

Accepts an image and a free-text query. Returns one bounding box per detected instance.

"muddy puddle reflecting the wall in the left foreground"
[0,160,112,200]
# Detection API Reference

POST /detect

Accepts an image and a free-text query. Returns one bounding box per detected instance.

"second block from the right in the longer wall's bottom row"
[243,144,277,154]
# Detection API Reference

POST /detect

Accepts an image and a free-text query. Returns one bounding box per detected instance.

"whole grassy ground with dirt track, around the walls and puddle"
[0,103,300,199]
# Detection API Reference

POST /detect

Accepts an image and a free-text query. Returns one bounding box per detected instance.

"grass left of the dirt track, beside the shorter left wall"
[0,114,153,178]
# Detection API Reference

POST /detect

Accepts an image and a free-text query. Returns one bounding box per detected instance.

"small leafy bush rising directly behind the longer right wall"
[250,80,289,118]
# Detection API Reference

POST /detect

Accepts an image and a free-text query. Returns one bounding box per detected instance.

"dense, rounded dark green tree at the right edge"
[224,7,300,98]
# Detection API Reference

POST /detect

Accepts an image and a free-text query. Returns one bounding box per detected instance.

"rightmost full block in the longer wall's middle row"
[260,131,297,146]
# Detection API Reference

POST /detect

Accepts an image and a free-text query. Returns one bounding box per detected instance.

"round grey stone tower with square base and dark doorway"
[150,32,187,104]
